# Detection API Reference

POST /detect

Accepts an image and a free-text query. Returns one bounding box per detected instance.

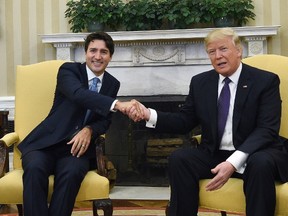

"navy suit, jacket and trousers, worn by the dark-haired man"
[18,63,120,216]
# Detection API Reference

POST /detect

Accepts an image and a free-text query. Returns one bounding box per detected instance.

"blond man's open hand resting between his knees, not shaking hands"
[206,161,236,191]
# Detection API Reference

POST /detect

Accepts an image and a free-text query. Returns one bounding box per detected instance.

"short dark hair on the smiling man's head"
[84,32,114,56]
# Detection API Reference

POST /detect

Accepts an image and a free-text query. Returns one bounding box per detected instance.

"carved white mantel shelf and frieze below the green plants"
[41,26,280,64]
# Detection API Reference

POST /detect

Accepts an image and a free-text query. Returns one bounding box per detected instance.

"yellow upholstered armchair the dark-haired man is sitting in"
[0,60,113,216]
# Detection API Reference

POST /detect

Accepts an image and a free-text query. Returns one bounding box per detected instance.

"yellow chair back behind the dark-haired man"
[13,60,64,169]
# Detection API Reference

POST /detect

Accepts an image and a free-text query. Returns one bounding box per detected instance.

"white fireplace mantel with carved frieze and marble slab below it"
[41,26,280,96]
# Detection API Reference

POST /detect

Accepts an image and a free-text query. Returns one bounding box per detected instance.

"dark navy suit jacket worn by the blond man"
[156,64,288,181]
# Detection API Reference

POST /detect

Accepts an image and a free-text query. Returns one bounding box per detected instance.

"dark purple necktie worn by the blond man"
[218,77,231,142]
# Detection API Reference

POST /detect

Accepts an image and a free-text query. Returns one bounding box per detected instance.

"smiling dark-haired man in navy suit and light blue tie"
[18,32,133,216]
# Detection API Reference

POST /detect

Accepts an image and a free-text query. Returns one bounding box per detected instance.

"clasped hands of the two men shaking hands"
[114,99,150,122]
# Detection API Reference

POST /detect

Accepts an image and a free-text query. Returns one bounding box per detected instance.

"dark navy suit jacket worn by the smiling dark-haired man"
[18,62,120,157]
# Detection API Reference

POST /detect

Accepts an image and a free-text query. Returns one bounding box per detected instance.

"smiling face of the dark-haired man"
[85,39,112,76]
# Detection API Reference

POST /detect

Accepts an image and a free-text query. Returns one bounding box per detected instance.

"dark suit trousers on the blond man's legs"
[169,148,278,216]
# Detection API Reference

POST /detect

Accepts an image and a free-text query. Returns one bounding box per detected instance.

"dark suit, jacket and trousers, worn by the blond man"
[156,64,288,216]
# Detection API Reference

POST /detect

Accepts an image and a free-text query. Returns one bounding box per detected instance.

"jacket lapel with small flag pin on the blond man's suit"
[233,64,253,134]
